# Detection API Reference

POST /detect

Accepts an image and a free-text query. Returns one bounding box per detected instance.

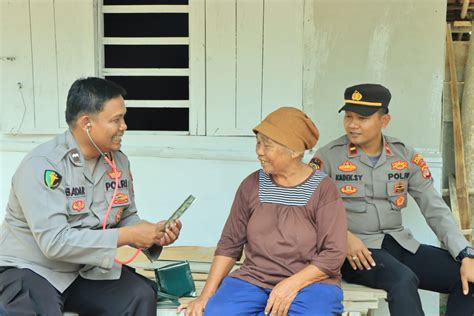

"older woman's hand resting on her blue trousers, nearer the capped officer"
[265,276,304,316]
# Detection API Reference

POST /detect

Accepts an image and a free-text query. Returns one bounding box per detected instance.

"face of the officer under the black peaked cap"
[344,111,390,149]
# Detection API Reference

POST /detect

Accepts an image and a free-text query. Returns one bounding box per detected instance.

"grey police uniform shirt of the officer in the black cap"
[310,136,469,258]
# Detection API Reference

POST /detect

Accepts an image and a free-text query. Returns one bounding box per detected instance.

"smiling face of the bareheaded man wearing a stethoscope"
[89,96,127,153]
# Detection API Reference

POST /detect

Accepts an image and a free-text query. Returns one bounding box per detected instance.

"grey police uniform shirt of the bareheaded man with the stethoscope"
[0,131,161,292]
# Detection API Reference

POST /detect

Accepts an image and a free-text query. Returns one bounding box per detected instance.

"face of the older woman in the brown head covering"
[255,133,294,174]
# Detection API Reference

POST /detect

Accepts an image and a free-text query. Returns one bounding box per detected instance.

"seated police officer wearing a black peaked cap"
[310,84,474,316]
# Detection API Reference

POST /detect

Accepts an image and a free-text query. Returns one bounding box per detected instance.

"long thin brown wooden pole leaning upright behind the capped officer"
[446,24,471,237]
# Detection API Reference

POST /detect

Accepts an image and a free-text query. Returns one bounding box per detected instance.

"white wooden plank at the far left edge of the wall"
[0,0,35,134]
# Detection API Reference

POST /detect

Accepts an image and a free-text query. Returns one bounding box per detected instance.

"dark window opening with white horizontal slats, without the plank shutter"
[101,0,190,134]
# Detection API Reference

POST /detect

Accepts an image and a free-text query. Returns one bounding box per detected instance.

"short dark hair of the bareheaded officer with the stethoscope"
[66,77,127,126]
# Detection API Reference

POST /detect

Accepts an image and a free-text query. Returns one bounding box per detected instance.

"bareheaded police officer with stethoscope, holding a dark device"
[0,78,181,316]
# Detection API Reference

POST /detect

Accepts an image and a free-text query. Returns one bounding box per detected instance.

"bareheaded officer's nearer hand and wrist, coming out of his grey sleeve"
[118,222,165,248]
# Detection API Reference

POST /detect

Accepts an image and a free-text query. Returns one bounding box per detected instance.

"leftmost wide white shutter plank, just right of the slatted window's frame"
[206,0,236,135]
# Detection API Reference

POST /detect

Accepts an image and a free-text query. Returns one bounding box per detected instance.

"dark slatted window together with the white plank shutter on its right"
[99,0,303,136]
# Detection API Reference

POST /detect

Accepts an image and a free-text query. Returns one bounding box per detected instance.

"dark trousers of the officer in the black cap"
[341,235,474,316]
